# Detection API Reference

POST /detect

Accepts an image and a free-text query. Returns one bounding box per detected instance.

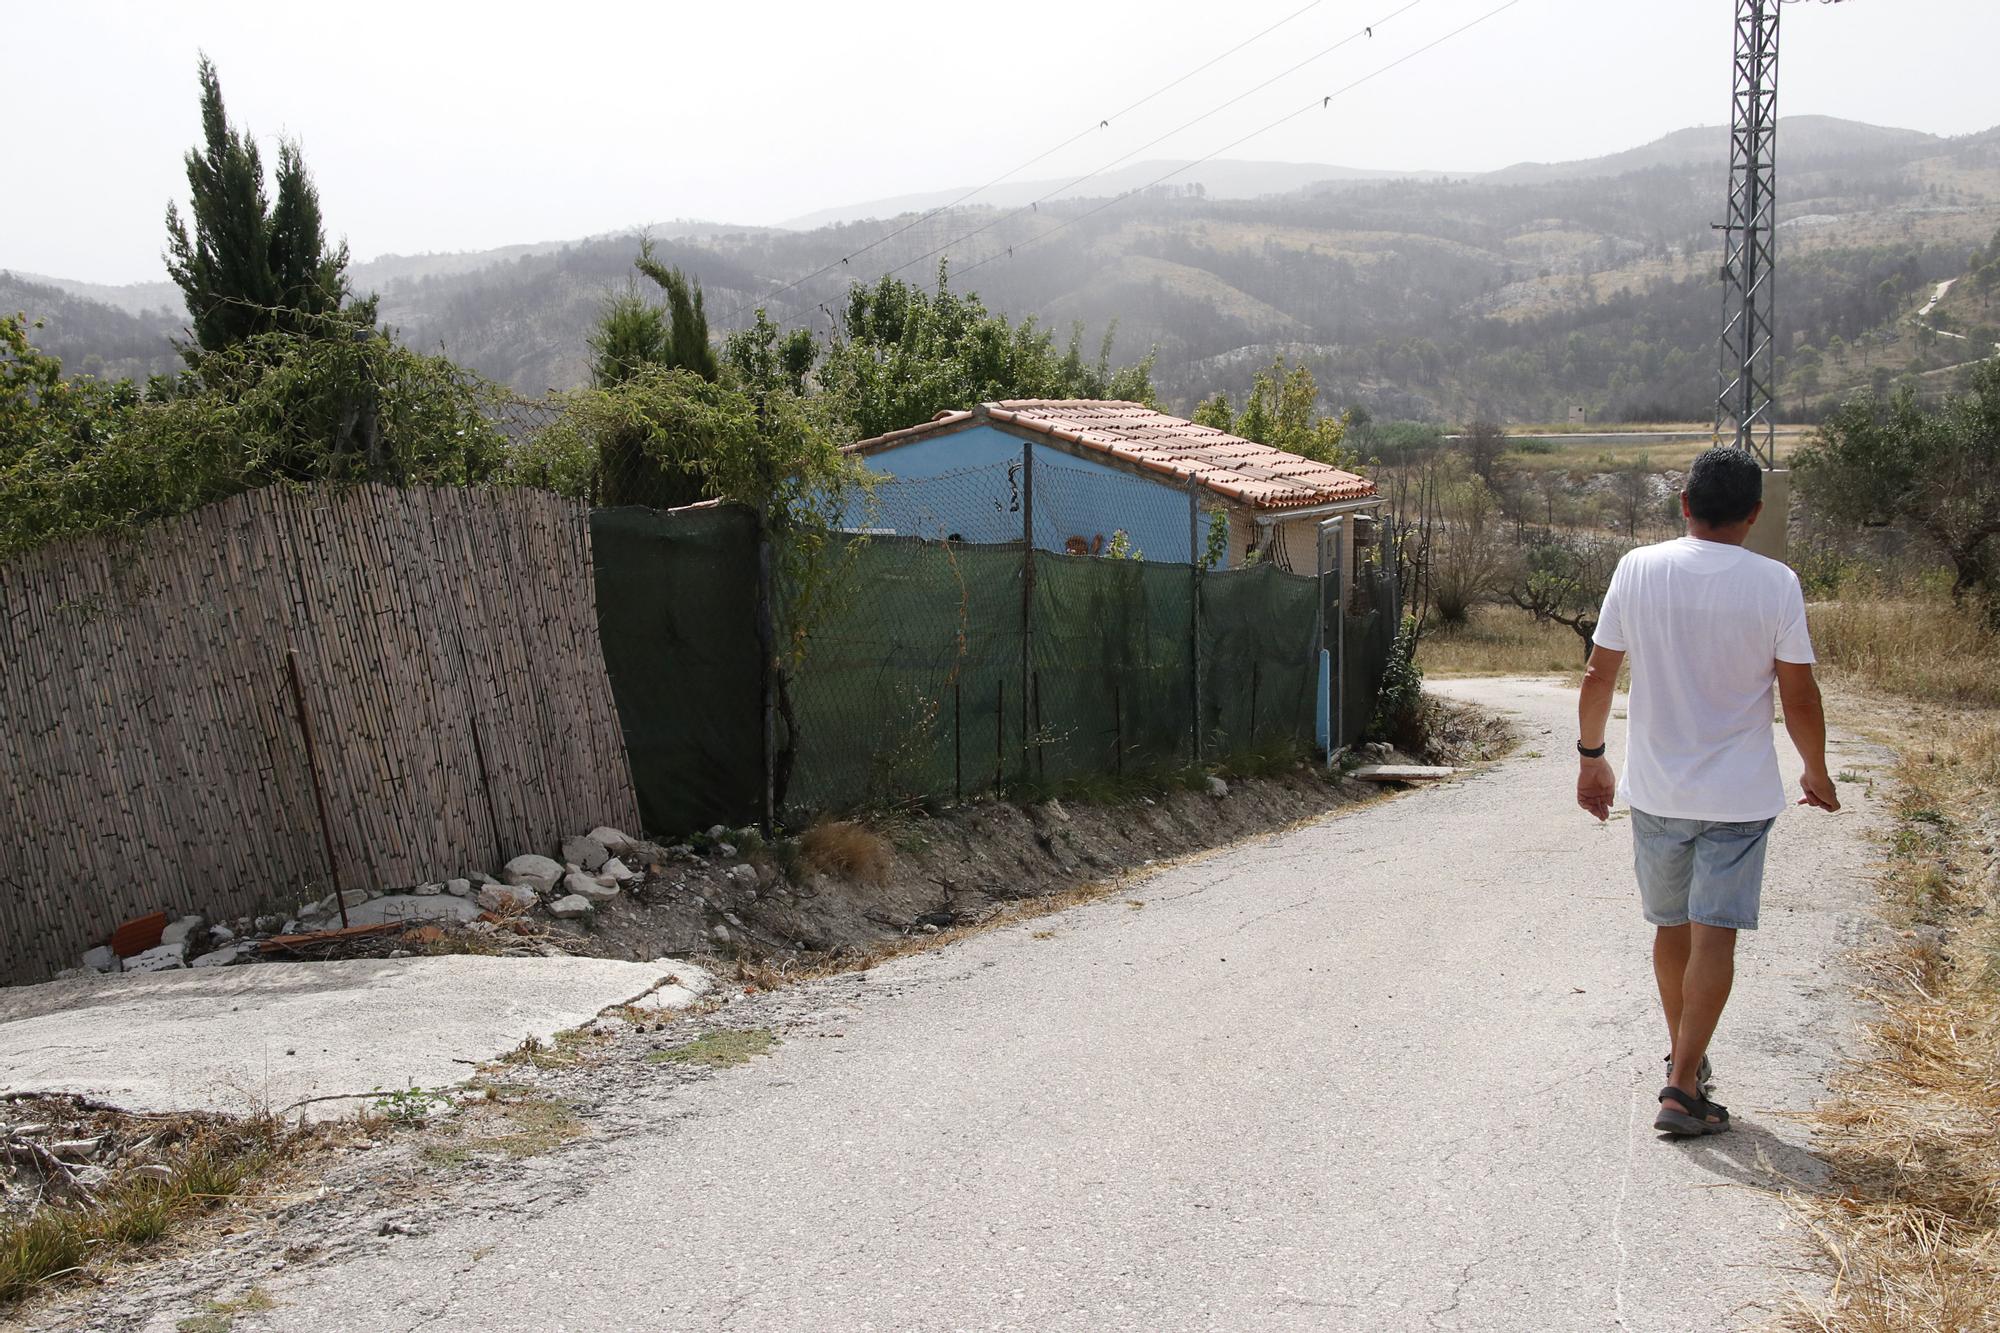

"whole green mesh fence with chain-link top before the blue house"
[592,468,1396,833]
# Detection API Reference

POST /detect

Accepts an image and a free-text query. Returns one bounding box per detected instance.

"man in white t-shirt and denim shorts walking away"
[1576,448,1840,1135]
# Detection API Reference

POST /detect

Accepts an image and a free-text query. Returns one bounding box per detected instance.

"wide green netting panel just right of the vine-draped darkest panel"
[780,536,1022,811]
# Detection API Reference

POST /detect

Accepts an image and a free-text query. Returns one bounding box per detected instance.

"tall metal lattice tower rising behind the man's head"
[1716,0,1782,468]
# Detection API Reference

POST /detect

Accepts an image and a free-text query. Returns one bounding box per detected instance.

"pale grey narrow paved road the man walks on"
[236,681,1882,1333]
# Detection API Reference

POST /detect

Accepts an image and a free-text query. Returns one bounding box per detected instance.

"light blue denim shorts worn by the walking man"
[1632,809,1776,931]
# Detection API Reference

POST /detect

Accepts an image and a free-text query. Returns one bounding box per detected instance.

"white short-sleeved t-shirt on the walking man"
[1592,536,1814,823]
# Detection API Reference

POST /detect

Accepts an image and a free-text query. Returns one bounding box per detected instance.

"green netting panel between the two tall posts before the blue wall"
[1028,554,1194,781]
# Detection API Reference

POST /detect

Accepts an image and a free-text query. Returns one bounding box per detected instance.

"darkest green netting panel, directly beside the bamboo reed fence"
[590,508,764,837]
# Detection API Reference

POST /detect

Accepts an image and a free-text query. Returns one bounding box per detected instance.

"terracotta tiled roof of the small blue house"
[848,398,1376,508]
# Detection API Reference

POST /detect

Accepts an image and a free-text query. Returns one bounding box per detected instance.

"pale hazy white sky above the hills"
[0,0,2000,282]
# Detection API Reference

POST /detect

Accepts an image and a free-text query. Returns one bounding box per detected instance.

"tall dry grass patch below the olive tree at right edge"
[1808,596,2000,709]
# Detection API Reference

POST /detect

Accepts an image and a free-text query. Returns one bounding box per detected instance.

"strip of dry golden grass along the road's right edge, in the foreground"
[1788,717,2000,1333]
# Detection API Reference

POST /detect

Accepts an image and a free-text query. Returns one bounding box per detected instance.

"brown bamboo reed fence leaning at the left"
[0,486,638,981]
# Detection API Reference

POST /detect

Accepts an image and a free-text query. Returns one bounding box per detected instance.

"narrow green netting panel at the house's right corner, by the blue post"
[1202,564,1320,757]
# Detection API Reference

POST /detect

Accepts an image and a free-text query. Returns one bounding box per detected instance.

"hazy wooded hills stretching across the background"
[10,116,2000,420]
